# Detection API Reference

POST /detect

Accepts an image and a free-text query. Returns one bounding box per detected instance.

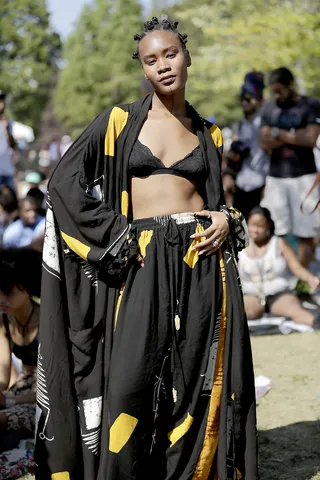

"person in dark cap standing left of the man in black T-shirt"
[223,71,270,217]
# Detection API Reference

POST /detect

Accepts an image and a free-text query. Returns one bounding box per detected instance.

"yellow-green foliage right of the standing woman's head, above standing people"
[165,0,320,125]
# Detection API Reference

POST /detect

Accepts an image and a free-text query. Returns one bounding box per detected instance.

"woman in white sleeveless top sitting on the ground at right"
[238,207,319,326]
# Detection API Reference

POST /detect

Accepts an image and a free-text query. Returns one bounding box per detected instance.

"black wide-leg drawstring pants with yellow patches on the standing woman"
[107,213,221,480]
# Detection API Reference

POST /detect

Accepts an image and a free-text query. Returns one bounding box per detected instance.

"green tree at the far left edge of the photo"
[0,0,61,131]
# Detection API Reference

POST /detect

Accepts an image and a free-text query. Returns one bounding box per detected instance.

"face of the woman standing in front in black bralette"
[139,30,188,95]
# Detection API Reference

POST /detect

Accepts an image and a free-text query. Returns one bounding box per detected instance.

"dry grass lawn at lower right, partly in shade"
[23,333,320,480]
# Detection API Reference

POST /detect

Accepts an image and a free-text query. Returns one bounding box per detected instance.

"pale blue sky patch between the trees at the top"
[47,0,149,39]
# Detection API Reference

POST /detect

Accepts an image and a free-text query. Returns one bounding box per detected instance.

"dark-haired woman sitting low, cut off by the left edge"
[0,249,41,449]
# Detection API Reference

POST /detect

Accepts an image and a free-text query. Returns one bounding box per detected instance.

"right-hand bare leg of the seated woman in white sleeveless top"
[270,293,314,326]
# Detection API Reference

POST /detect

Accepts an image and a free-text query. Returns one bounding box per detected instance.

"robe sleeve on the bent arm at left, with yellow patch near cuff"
[48,110,130,268]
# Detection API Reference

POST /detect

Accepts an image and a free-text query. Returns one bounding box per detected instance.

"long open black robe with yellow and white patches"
[35,96,258,480]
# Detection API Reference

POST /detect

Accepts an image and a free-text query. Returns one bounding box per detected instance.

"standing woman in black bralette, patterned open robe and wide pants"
[35,18,257,480]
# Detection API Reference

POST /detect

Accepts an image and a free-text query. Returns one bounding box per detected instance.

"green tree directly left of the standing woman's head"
[54,0,143,135]
